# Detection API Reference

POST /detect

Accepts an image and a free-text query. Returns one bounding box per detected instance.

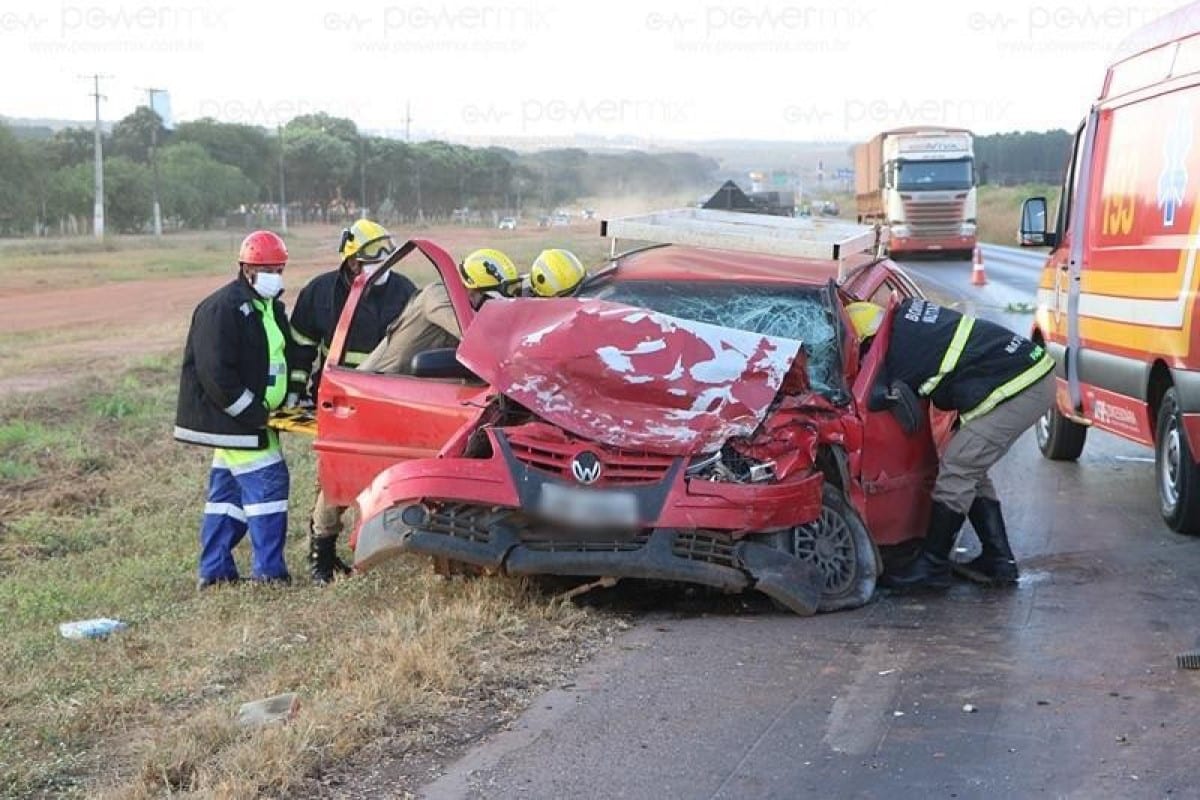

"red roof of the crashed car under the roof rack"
[617,245,876,285]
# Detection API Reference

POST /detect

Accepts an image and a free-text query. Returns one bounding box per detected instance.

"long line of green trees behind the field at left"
[0,112,718,235]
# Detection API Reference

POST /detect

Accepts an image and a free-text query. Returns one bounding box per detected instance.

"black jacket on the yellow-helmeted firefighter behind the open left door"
[290,267,416,395]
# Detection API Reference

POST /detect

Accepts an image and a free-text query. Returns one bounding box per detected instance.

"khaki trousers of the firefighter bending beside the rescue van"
[932,371,1055,513]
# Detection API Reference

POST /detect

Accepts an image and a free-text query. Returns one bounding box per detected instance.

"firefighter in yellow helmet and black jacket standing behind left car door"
[288,219,416,583]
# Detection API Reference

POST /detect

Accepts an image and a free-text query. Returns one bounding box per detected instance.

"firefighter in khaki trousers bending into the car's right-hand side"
[846,297,1055,591]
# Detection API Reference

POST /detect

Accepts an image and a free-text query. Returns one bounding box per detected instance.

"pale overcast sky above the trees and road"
[0,0,1178,143]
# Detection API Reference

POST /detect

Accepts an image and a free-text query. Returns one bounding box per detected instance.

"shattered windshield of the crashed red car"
[582,281,844,398]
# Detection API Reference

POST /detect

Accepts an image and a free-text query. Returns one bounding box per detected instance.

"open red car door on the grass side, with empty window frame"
[313,239,487,505]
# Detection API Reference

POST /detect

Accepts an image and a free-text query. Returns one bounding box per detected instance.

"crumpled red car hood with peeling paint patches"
[458,299,803,456]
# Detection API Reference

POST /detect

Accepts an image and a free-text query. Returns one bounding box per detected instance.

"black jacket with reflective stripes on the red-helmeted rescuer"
[175,276,292,450]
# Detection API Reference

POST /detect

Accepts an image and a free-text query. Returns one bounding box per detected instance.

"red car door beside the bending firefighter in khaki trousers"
[852,296,947,546]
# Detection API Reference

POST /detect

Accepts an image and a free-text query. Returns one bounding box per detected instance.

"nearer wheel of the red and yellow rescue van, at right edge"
[1154,386,1200,535]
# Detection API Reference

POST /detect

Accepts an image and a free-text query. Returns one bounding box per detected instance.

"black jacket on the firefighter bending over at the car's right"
[884,297,1045,414]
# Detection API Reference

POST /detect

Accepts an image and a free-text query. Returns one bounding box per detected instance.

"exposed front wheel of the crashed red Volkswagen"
[781,483,881,612]
